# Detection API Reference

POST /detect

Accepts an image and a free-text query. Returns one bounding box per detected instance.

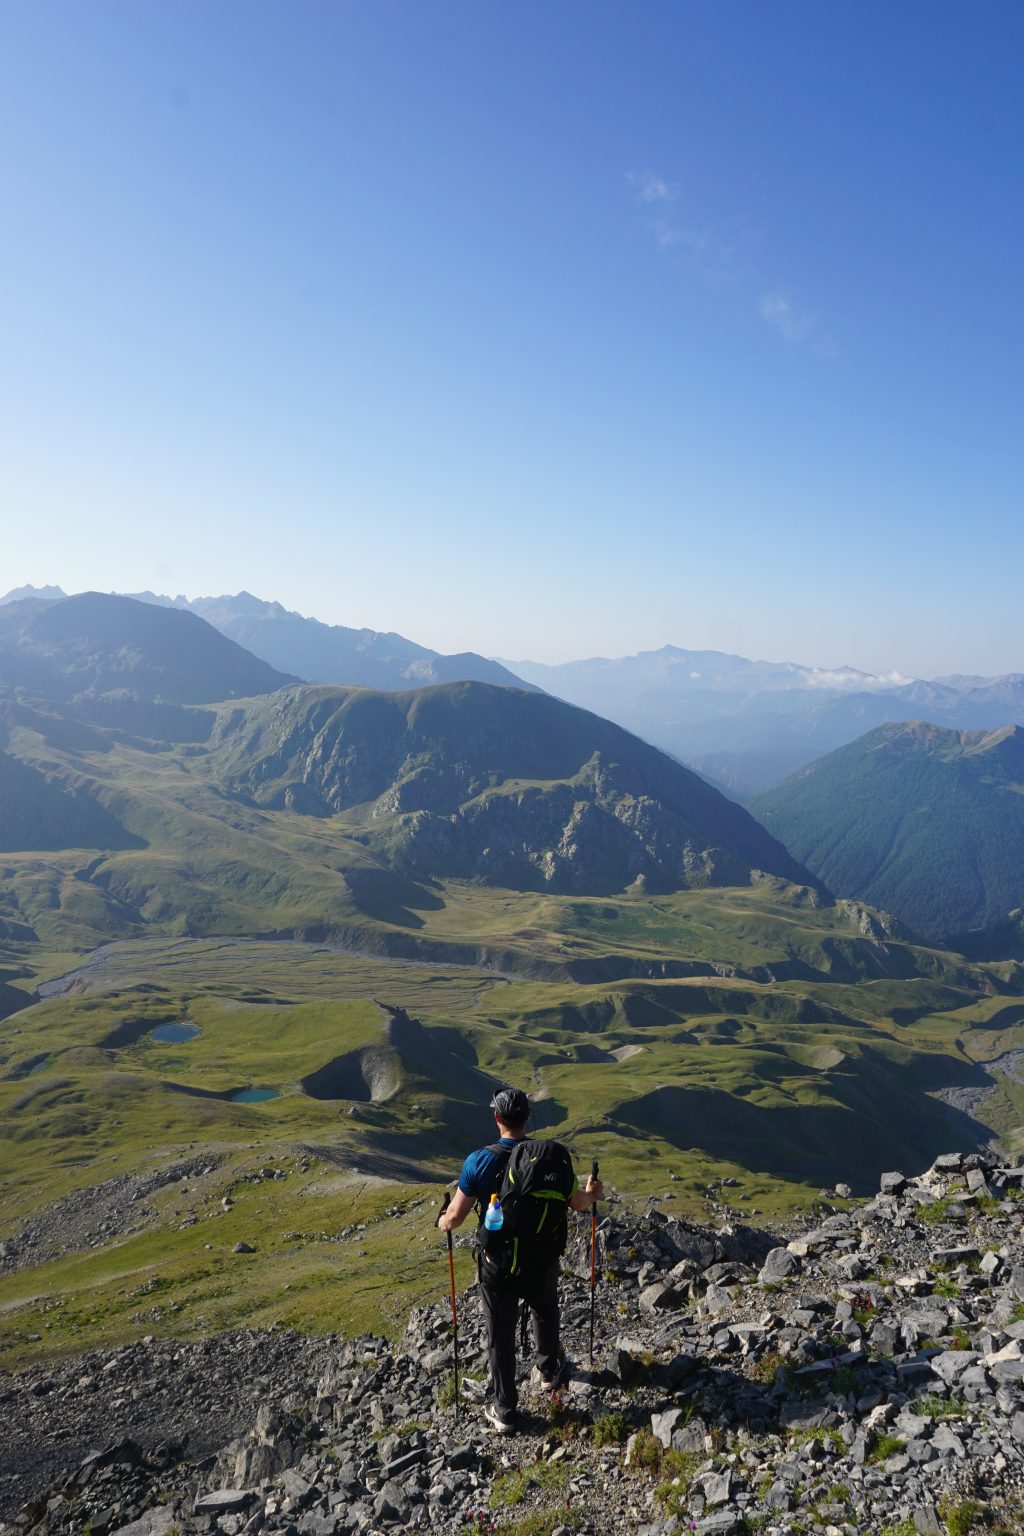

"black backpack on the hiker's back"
[479,1140,576,1279]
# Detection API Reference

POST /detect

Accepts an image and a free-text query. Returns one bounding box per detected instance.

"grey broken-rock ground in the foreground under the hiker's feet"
[0,1152,1024,1536]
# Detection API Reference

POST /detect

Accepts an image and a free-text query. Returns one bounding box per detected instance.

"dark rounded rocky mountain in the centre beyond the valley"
[212,682,814,894]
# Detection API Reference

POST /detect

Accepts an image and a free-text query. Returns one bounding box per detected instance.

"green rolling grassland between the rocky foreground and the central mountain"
[0,706,1024,1359]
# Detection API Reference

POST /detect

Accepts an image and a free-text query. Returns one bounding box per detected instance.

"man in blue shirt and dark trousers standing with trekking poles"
[438,1087,605,1435]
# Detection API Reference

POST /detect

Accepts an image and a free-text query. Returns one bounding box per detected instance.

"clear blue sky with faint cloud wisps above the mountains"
[0,0,1024,674]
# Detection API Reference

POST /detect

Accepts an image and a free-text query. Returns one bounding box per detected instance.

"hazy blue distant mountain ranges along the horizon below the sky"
[10,588,1024,800]
